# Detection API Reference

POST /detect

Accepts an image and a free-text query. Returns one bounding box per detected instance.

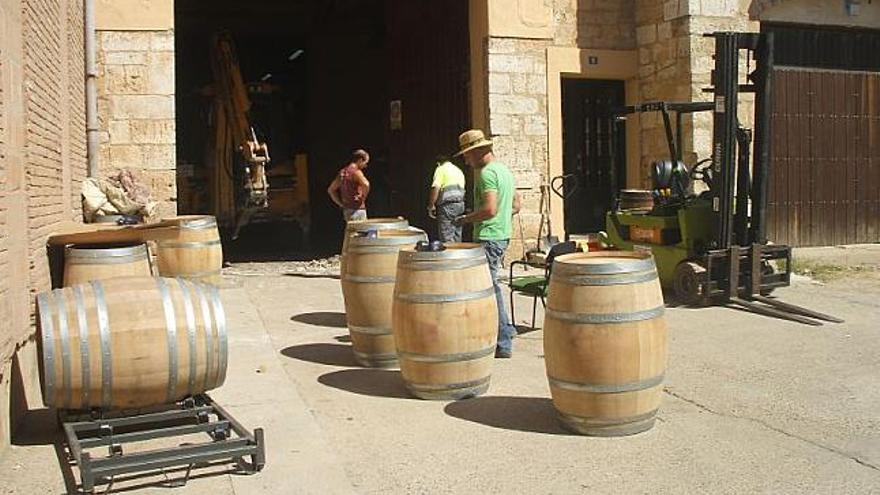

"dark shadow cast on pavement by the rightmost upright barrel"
[444,397,570,435]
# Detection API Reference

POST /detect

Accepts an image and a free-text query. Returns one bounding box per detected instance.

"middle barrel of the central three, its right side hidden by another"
[342,228,428,368]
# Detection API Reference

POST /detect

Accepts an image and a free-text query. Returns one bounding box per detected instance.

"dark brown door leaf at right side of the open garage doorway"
[386,0,471,228]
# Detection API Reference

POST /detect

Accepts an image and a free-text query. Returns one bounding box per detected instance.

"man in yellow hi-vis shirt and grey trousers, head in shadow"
[428,157,465,243]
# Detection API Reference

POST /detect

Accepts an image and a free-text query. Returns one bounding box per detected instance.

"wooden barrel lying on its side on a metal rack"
[36,277,227,410]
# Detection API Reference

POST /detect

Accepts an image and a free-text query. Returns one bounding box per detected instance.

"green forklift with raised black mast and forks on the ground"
[606,32,842,325]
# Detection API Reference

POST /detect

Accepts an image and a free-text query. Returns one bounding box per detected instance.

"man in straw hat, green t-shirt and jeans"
[455,129,520,358]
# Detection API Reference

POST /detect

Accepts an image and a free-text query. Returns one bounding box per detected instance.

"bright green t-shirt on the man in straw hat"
[474,161,514,241]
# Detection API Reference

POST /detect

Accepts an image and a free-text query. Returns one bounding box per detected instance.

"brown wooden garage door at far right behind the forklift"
[767,67,880,246]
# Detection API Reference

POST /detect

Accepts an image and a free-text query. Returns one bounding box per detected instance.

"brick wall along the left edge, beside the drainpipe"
[0,0,86,451]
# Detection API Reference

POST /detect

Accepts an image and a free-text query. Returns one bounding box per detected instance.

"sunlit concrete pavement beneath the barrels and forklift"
[0,265,880,495]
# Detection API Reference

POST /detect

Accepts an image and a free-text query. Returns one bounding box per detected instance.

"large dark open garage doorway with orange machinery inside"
[175,0,470,258]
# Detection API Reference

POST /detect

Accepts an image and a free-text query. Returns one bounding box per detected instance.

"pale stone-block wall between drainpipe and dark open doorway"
[97,30,177,216]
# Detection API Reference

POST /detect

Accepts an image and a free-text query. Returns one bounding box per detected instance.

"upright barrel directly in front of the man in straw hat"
[391,244,498,400]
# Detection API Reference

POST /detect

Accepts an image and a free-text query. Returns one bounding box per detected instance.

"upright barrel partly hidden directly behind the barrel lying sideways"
[64,244,150,287]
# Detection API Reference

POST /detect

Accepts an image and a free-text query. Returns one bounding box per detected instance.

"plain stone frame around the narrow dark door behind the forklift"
[546,47,642,238]
